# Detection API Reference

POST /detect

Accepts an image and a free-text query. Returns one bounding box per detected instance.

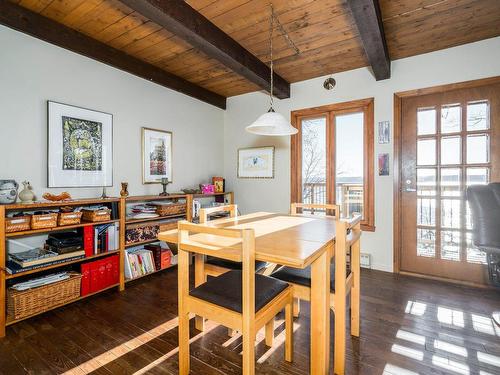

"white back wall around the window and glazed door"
[224,37,500,271]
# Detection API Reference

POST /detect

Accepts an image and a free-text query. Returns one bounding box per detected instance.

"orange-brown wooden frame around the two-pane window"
[290,98,375,232]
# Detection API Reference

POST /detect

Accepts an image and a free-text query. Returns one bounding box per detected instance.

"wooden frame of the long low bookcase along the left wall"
[0,192,230,338]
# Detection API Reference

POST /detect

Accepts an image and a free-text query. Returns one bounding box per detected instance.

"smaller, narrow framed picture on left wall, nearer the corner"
[141,128,172,184]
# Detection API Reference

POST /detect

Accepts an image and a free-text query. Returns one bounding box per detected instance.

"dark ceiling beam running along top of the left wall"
[0,0,226,109]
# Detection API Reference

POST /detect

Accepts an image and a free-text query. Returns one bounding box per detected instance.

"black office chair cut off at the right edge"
[467,182,500,326]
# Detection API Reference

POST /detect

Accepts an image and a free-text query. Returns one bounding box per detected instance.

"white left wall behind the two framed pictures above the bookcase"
[0,26,224,197]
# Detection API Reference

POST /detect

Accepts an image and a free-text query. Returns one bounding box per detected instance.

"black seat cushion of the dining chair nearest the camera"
[189,270,288,313]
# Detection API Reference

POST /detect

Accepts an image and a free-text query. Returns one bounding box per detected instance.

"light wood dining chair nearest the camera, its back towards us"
[178,221,293,375]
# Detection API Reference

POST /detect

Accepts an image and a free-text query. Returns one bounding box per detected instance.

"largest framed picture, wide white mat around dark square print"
[47,101,113,188]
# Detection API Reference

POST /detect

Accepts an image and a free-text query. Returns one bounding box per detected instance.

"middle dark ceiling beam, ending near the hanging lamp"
[121,0,290,99]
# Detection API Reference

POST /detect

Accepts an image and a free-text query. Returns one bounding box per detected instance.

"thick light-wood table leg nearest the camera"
[311,249,330,375]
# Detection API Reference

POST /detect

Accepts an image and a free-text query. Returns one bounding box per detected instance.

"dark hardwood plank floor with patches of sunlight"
[0,268,500,375]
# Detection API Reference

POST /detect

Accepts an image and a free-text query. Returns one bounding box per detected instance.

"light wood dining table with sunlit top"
[158,212,345,375]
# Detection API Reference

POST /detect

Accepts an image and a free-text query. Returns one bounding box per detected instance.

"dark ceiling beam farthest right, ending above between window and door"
[347,0,391,81]
